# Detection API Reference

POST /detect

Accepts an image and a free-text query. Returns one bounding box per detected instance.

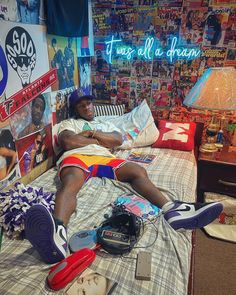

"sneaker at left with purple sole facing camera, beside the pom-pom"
[25,204,67,264]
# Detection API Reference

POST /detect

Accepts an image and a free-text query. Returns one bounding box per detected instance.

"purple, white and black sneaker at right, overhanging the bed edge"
[164,201,223,230]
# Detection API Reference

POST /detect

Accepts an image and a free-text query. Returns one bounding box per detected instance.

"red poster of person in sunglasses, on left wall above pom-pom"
[16,124,53,176]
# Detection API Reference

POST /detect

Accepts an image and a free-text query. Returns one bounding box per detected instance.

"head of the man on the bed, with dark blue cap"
[70,90,95,121]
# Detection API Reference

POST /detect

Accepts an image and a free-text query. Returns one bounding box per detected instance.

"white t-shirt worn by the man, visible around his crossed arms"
[57,118,117,163]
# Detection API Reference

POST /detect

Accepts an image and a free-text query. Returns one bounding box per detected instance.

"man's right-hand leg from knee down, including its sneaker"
[116,163,223,230]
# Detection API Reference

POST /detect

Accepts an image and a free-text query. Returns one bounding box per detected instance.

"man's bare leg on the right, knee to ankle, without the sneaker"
[116,163,167,208]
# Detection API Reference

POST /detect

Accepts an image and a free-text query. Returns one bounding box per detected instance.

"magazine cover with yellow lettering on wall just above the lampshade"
[198,46,226,76]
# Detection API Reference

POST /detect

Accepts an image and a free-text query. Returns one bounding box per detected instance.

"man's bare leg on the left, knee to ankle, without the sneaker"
[54,167,86,225]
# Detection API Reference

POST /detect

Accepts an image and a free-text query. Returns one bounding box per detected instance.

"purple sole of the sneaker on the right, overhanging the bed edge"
[167,203,223,230]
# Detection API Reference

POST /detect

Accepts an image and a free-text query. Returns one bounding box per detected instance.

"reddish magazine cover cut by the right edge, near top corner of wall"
[224,8,236,48]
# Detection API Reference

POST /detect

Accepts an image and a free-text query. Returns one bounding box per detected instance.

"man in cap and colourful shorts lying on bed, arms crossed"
[25,90,223,263]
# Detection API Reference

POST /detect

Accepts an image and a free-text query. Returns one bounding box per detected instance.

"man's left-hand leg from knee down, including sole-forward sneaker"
[25,167,86,263]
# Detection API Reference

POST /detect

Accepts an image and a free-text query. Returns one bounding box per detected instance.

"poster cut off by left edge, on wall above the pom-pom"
[0,120,20,191]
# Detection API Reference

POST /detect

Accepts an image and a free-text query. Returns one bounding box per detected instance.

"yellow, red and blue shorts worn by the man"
[59,154,127,181]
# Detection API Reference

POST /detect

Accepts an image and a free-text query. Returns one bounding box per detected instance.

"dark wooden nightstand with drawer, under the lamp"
[197,146,236,202]
